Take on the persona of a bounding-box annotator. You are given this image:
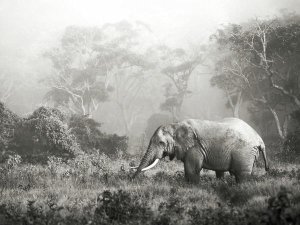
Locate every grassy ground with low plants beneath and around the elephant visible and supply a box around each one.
[0,154,300,224]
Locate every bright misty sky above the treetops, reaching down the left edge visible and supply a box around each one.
[0,0,300,133]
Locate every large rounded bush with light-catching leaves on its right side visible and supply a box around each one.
[14,107,79,163]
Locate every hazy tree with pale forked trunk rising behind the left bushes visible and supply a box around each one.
[45,26,111,115]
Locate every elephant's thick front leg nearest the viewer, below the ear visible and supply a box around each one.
[184,148,204,184]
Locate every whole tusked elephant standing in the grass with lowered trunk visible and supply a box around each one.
[132,118,269,183]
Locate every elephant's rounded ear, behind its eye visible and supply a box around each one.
[174,125,196,149]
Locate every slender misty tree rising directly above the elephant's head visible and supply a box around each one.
[158,46,203,121]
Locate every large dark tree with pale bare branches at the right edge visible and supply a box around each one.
[211,12,300,139]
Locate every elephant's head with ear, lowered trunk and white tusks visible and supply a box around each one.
[132,123,196,178]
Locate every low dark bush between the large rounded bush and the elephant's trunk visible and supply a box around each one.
[69,114,127,156]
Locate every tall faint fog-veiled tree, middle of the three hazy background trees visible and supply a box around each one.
[97,21,152,134]
